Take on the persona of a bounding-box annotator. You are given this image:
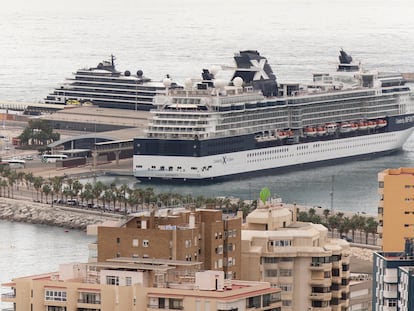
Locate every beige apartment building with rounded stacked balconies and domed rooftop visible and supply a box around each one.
[241,204,350,311]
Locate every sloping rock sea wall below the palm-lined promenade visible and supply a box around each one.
[0,197,120,230]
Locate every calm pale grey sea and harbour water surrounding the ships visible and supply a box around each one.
[0,0,414,304]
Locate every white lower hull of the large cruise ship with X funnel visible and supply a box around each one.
[133,115,414,181]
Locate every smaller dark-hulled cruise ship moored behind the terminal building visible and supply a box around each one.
[45,55,180,110]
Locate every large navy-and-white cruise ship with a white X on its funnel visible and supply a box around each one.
[133,50,414,181]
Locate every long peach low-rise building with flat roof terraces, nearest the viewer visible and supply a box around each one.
[2,258,281,311]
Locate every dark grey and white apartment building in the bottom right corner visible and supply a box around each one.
[372,238,414,311]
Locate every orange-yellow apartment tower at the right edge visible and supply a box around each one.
[377,167,414,252]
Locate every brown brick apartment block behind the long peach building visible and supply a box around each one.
[90,209,242,279]
